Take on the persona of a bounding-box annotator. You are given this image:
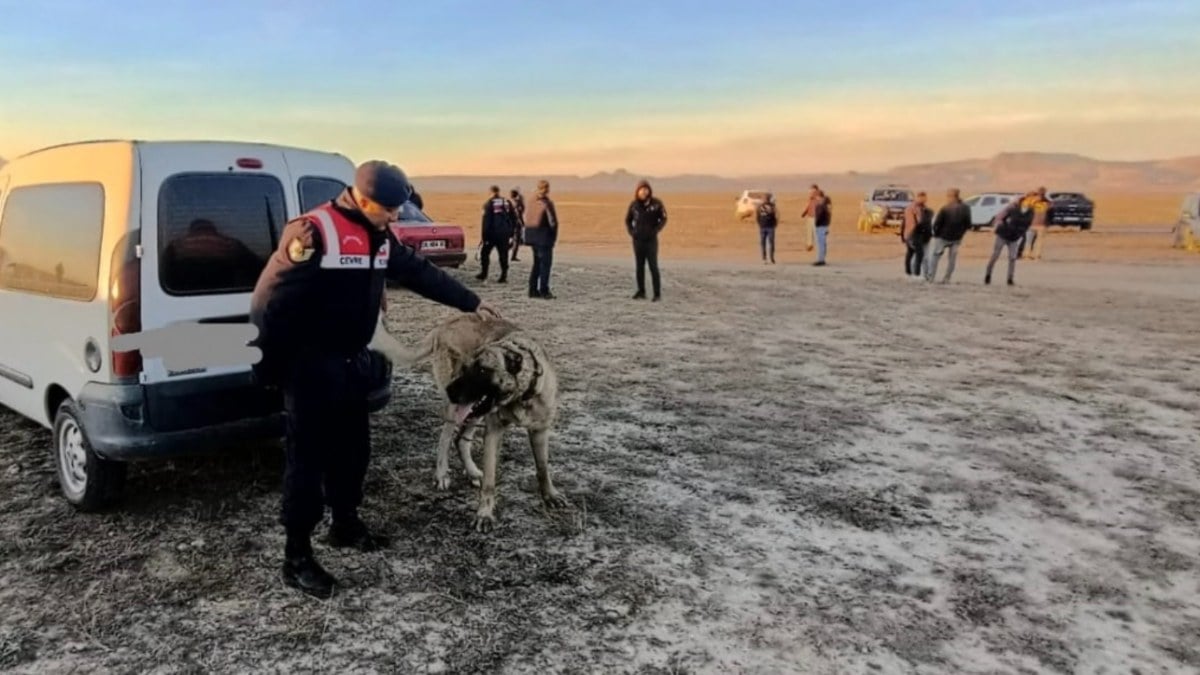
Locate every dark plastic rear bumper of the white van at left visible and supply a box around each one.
[79,372,284,461]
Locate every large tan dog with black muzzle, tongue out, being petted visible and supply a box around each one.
[371,313,568,532]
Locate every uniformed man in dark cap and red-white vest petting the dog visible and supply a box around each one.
[251,161,497,598]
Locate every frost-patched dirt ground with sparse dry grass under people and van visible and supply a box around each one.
[0,198,1200,675]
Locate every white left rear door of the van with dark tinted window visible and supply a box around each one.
[139,143,295,383]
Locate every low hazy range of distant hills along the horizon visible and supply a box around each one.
[413,153,1200,193]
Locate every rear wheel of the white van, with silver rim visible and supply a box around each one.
[54,399,127,512]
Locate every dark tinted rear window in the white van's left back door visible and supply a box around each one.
[158,173,287,295]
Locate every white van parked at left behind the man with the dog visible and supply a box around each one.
[0,141,386,510]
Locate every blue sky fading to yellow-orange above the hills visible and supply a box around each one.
[0,0,1200,174]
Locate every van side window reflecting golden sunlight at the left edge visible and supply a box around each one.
[0,183,104,301]
